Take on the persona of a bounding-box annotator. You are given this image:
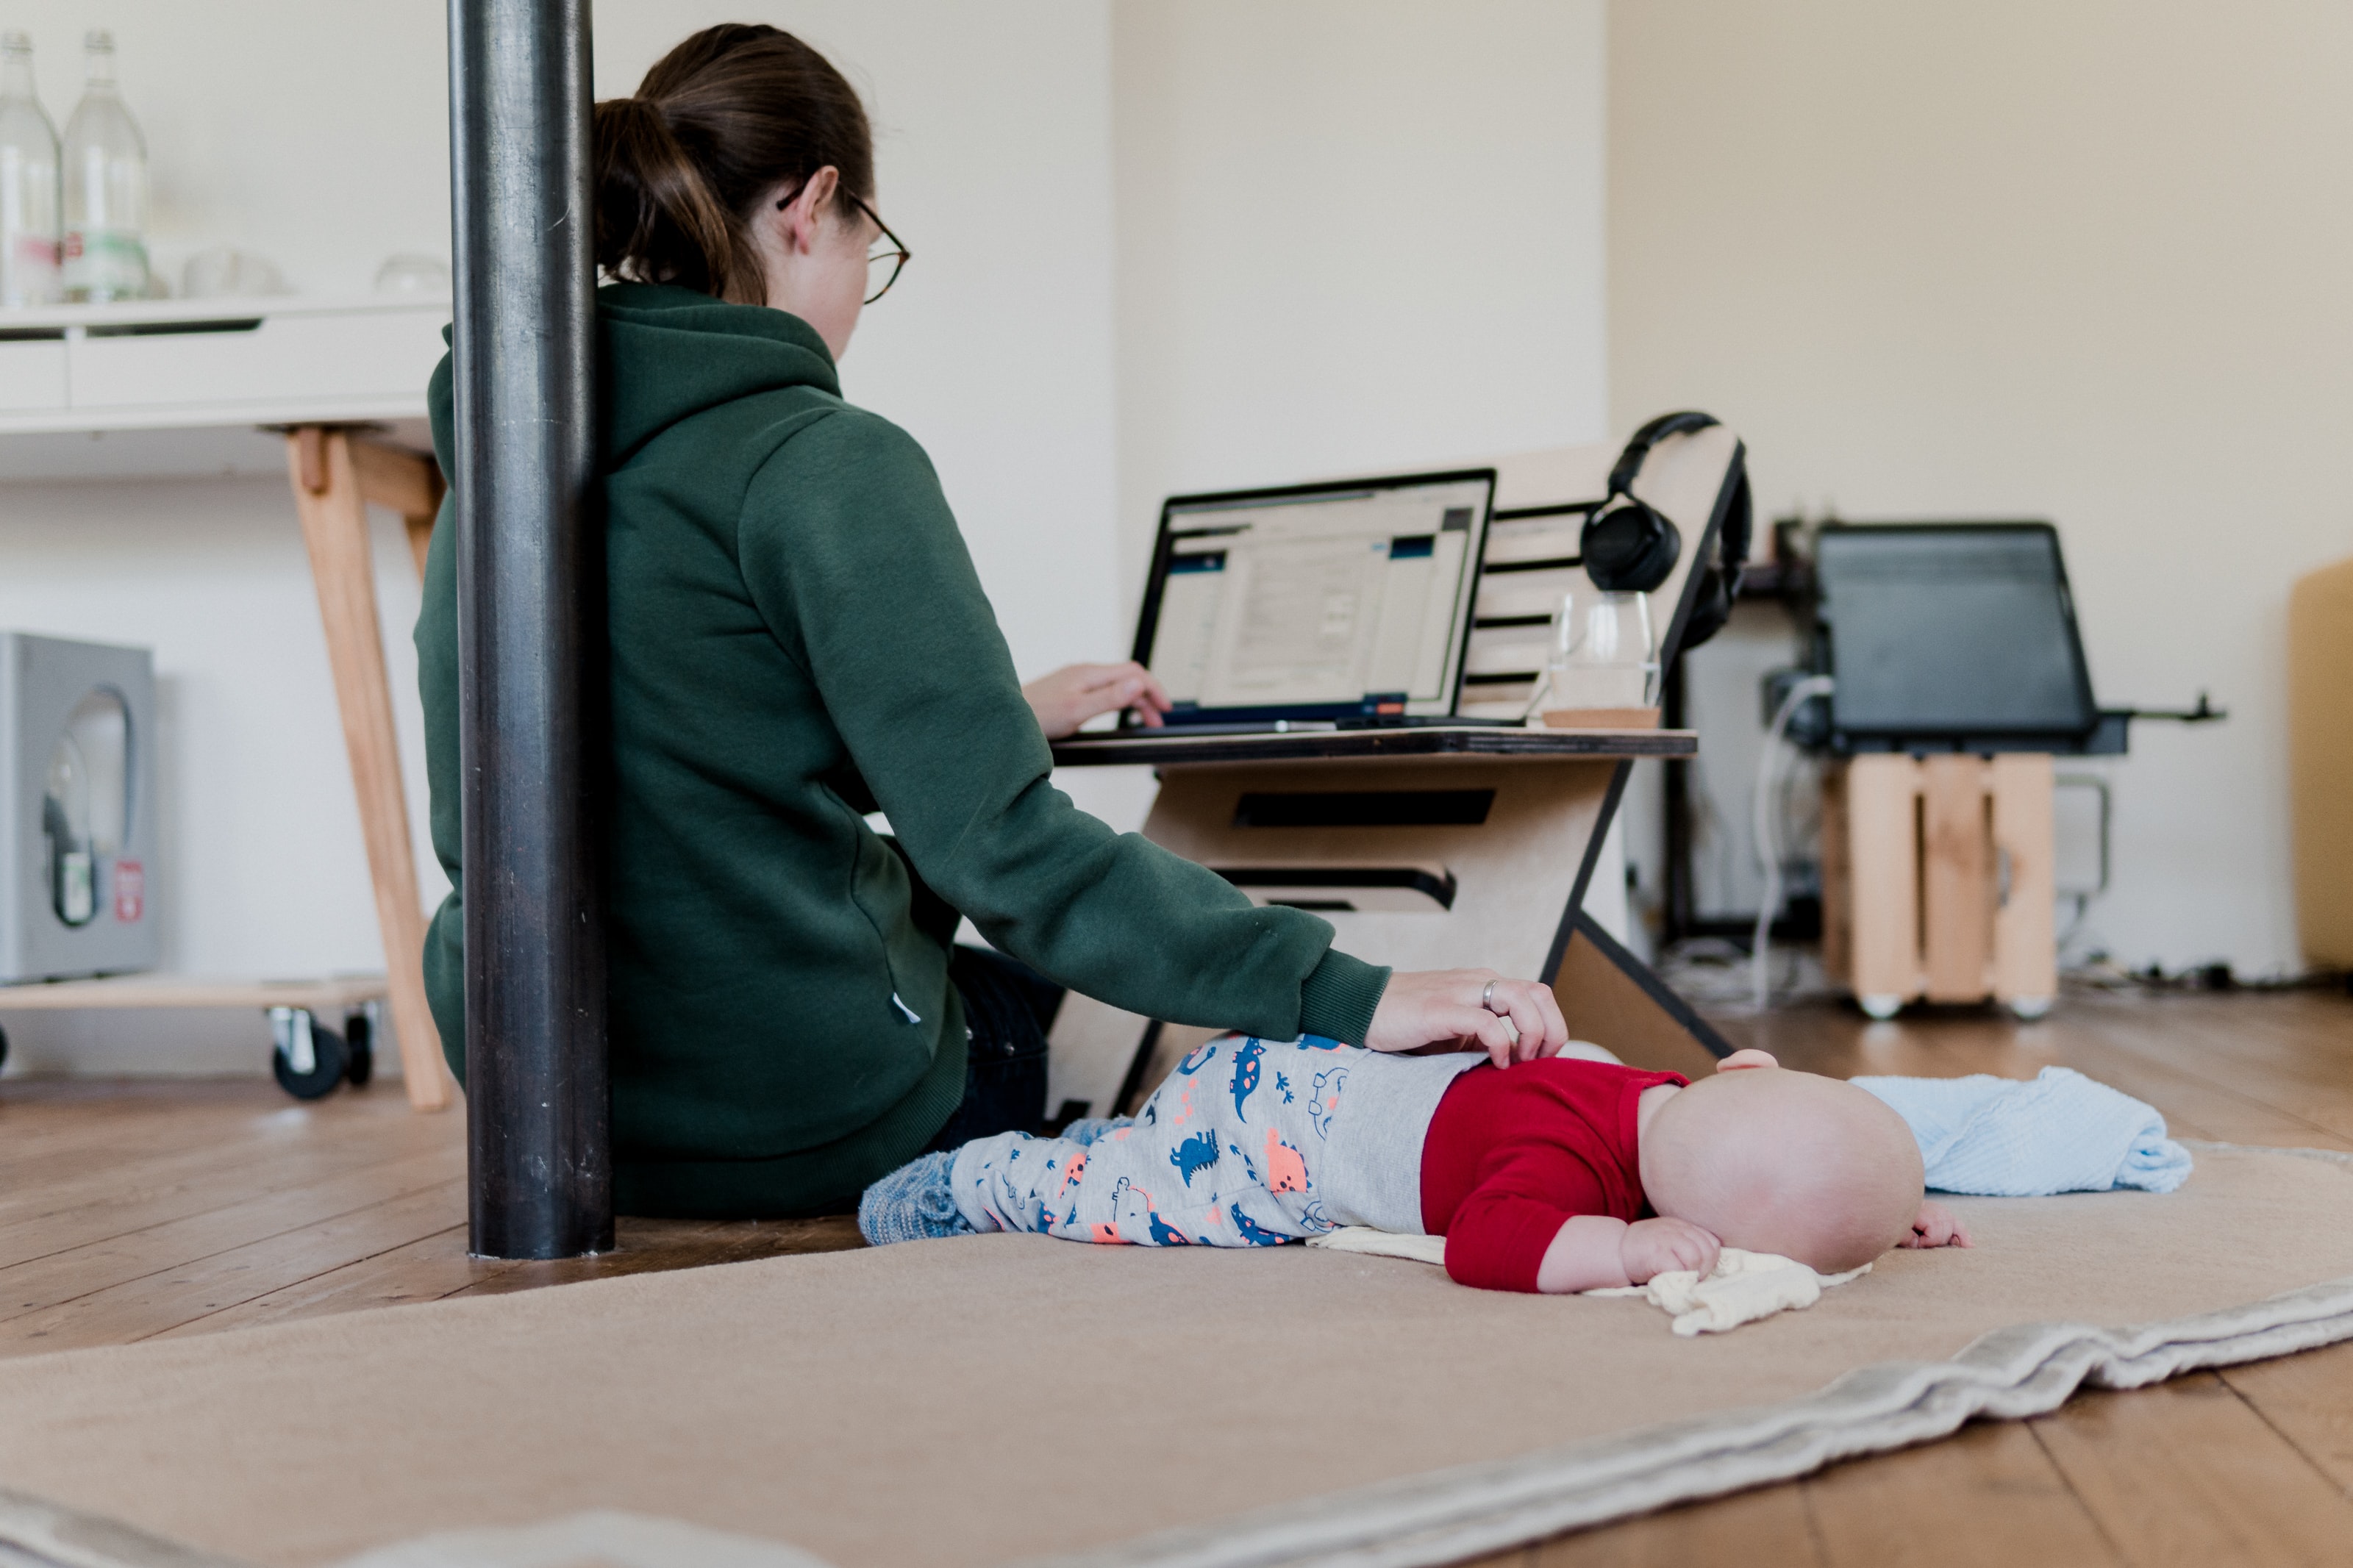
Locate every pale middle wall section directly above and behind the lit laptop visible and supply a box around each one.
[1113,0,1604,606]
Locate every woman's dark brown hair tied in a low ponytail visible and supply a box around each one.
[596,21,875,306]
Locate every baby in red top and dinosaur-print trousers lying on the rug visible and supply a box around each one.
[859,1034,1969,1293]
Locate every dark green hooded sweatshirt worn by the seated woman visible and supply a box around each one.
[416,284,1388,1215]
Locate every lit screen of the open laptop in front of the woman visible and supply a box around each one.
[1137,468,1494,724]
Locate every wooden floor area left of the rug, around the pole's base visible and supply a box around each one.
[0,1079,861,1356]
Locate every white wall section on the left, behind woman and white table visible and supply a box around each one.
[0,0,1125,1070]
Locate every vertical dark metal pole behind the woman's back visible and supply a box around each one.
[449,0,612,1258]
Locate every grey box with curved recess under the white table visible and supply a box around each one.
[0,632,160,983]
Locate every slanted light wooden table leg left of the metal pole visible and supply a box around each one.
[287,426,449,1109]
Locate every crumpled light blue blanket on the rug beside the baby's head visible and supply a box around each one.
[1854,1067,2190,1197]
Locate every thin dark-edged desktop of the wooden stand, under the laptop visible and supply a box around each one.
[1054,724,1699,769]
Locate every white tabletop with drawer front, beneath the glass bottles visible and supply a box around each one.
[0,294,449,479]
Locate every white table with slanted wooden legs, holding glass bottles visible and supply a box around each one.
[0,296,451,1109]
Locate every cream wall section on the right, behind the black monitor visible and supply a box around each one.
[1610,0,2353,969]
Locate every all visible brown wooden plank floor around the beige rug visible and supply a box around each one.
[0,995,2353,1568]
